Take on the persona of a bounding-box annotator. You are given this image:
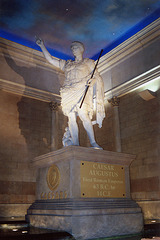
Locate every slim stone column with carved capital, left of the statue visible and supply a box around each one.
[49,102,59,151]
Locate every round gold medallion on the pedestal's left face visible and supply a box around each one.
[47,164,60,191]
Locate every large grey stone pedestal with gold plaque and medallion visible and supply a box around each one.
[26,146,143,239]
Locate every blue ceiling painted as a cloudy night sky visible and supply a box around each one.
[0,0,160,59]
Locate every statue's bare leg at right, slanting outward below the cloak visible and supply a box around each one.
[78,109,102,149]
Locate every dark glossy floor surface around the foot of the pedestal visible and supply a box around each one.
[0,218,160,240]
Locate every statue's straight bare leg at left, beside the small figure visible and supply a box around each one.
[68,112,79,146]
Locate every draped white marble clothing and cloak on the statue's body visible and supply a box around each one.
[60,58,105,127]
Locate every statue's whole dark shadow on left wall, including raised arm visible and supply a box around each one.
[4,46,51,159]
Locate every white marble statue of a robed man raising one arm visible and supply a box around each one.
[36,38,105,149]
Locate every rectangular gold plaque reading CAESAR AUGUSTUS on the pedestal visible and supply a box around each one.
[81,161,126,198]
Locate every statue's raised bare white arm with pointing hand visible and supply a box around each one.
[36,37,59,68]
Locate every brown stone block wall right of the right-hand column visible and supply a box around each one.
[119,89,160,219]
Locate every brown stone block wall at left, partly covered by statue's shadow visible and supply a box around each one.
[0,90,51,216]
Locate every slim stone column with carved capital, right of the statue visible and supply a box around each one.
[108,96,121,152]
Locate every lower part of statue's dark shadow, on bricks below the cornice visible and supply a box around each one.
[17,97,51,159]
